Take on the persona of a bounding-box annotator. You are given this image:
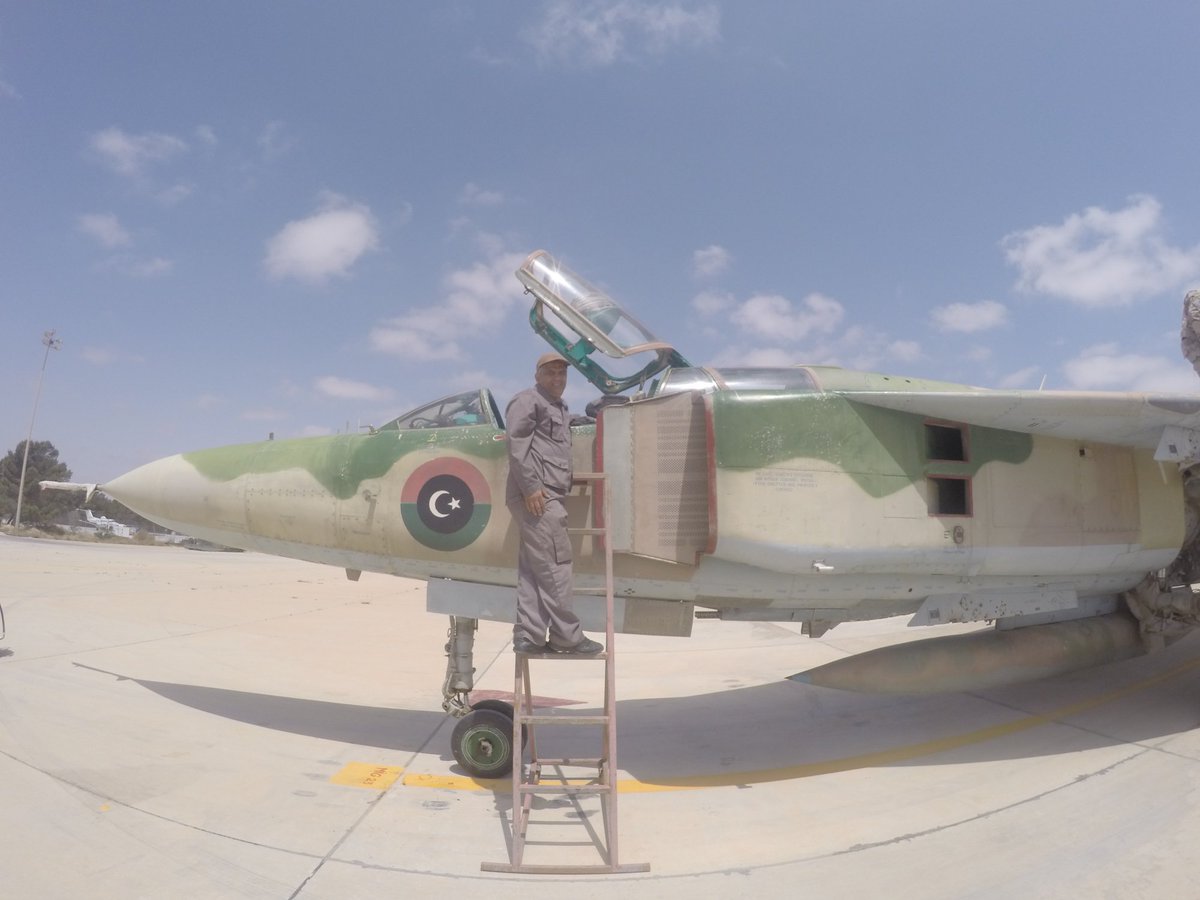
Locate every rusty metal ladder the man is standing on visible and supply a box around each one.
[480,472,650,875]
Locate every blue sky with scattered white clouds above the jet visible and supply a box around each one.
[0,0,1200,481]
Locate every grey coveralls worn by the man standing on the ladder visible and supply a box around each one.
[504,386,583,649]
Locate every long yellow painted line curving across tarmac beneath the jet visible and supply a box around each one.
[386,659,1200,793]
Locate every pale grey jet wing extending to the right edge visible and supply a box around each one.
[839,391,1200,458]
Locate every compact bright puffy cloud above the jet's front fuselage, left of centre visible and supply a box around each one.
[263,192,379,283]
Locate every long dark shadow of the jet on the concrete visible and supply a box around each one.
[76,648,1200,785]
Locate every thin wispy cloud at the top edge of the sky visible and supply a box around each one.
[523,0,721,66]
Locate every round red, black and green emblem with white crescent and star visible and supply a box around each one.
[400,456,492,551]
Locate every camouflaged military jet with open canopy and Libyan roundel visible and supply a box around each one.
[49,251,1200,775]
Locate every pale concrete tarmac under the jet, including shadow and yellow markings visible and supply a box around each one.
[0,535,1200,900]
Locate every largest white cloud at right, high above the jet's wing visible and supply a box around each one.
[1002,194,1200,307]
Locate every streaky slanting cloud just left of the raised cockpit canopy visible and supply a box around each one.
[370,250,524,361]
